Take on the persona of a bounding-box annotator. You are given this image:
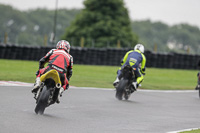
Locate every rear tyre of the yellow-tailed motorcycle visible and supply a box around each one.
[35,86,50,115]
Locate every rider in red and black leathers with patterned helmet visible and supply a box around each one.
[32,40,73,103]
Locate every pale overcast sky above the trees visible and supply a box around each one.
[0,0,200,28]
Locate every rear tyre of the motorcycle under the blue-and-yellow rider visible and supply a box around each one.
[115,78,128,100]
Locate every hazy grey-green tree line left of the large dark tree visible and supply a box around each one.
[0,4,80,46]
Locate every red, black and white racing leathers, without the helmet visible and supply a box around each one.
[36,49,73,90]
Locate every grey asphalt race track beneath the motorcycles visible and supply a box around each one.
[0,86,200,133]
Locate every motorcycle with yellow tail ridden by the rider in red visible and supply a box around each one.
[35,69,62,114]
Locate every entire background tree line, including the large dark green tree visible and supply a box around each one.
[0,0,200,54]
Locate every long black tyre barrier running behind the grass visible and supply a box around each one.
[0,44,200,69]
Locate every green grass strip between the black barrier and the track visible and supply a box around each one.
[0,59,198,90]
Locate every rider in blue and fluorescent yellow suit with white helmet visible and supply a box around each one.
[113,44,146,89]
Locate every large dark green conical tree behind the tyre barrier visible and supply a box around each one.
[63,0,138,47]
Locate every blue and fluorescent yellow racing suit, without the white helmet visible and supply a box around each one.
[117,50,146,85]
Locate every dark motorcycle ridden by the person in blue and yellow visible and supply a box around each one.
[115,65,136,100]
